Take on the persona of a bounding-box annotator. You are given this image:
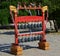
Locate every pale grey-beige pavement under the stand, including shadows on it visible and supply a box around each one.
[0,30,60,56]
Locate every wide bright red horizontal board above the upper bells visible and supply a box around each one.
[15,16,44,23]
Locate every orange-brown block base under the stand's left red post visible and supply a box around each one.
[11,43,23,55]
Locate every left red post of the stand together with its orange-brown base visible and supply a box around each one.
[11,12,23,55]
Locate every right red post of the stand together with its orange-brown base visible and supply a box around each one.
[38,12,49,50]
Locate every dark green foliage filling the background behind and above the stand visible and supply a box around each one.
[0,0,60,25]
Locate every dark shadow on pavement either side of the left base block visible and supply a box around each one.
[0,44,38,54]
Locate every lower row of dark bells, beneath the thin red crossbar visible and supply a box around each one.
[19,35,42,43]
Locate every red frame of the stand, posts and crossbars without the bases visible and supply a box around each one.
[12,8,46,44]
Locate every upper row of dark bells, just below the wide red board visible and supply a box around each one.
[18,23,42,29]
